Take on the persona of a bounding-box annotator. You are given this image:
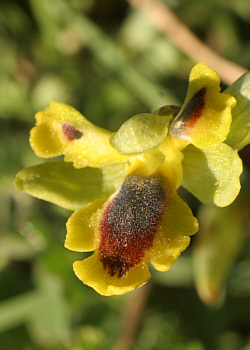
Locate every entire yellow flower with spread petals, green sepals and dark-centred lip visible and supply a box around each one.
[15,62,246,295]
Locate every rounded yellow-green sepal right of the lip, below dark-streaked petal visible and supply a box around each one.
[182,143,242,207]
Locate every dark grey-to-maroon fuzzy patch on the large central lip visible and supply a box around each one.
[99,173,166,278]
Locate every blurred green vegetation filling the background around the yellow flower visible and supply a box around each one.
[0,0,250,350]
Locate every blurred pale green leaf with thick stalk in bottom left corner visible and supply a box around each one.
[0,270,71,346]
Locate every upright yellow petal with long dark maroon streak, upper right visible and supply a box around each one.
[171,62,236,149]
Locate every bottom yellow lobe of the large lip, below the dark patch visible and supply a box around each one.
[73,252,150,296]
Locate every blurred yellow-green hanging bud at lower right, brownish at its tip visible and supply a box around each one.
[193,198,249,304]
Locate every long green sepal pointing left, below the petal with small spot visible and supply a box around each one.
[14,161,126,210]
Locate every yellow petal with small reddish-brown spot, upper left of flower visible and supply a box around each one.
[30,102,128,168]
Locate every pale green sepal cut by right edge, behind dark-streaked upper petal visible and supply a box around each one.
[224,72,250,149]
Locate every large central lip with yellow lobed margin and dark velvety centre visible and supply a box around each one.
[65,161,198,295]
